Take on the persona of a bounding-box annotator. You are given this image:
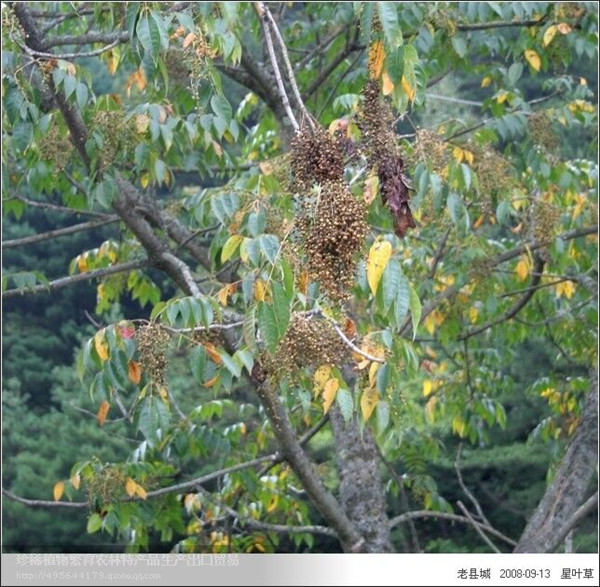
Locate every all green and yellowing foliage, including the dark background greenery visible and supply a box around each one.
[2,2,598,552]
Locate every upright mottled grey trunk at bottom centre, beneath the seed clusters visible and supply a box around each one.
[330,406,393,553]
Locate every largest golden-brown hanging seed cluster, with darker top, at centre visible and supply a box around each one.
[291,129,368,301]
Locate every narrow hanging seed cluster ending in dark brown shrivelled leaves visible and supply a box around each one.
[359,79,416,238]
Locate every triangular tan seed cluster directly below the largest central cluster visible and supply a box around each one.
[267,314,350,375]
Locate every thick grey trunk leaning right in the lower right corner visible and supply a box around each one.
[515,371,598,552]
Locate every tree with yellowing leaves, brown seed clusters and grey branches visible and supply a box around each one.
[3,2,598,552]
